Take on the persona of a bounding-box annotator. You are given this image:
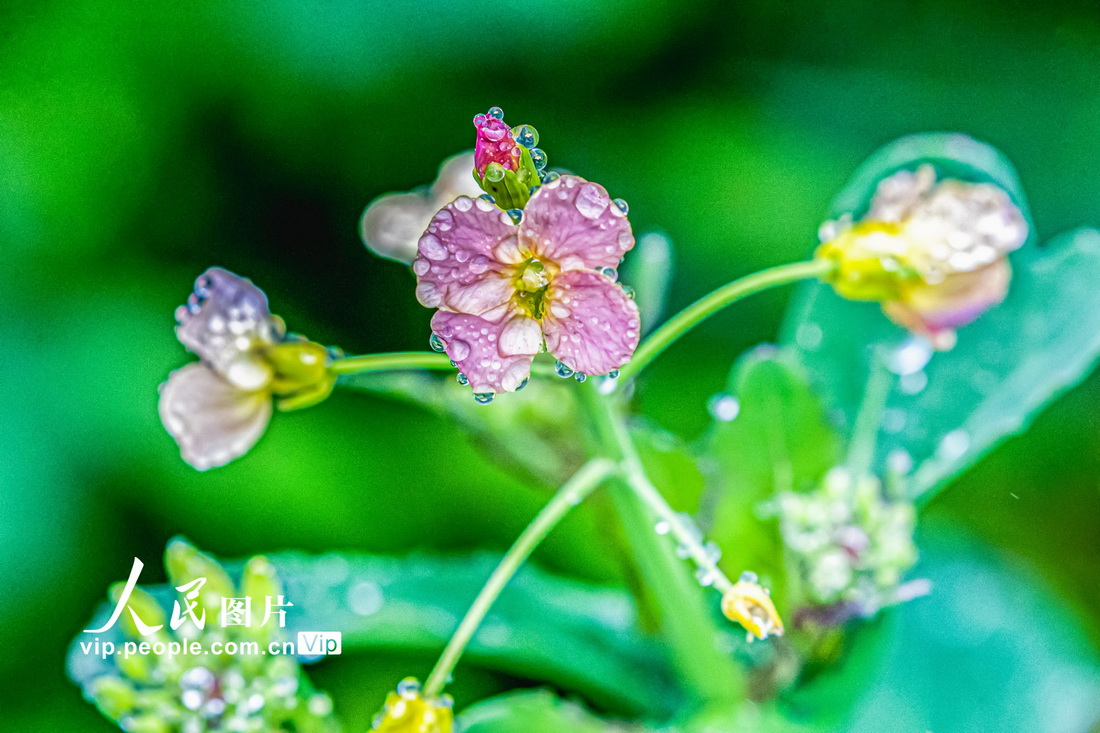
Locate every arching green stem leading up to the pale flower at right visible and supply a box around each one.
[619,260,835,384]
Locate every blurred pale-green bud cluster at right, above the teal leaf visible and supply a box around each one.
[778,468,920,619]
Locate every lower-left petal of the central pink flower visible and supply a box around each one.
[431,306,542,393]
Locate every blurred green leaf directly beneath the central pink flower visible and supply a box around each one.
[339,372,585,485]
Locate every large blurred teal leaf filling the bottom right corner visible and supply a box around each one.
[789,522,1100,733]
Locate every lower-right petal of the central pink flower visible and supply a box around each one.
[542,270,640,374]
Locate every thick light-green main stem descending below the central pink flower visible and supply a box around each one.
[576,383,743,705]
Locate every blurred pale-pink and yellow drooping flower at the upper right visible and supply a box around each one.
[816,165,1027,349]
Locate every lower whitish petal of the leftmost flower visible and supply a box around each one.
[160,363,272,471]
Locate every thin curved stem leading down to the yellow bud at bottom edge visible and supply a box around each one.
[424,459,615,700]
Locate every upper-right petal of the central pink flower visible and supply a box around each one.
[520,176,634,270]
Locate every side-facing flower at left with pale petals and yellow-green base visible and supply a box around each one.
[160,267,336,471]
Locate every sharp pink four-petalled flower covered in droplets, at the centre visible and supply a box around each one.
[413,176,639,393]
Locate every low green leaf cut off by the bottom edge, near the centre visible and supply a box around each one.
[458,690,646,733]
